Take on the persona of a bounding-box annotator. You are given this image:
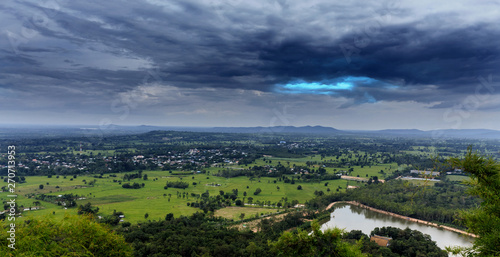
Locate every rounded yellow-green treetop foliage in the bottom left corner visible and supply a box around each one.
[0,215,133,257]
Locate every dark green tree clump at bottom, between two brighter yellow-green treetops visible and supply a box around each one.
[120,210,302,257]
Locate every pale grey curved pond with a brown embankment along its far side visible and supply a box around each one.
[321,203,474,249]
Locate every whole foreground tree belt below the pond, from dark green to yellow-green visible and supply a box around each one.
[119,209,447,257]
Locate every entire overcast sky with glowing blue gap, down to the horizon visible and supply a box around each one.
[0,0,500,130]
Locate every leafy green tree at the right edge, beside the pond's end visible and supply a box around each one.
[447,146,500,256]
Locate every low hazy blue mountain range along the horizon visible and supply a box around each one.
[0,125,500,139]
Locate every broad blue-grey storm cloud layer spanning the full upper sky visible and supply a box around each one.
[0,0,500,115]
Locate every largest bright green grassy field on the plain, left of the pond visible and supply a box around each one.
[0,171,355,222]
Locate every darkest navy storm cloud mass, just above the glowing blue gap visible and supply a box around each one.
[254,25,500,100]
